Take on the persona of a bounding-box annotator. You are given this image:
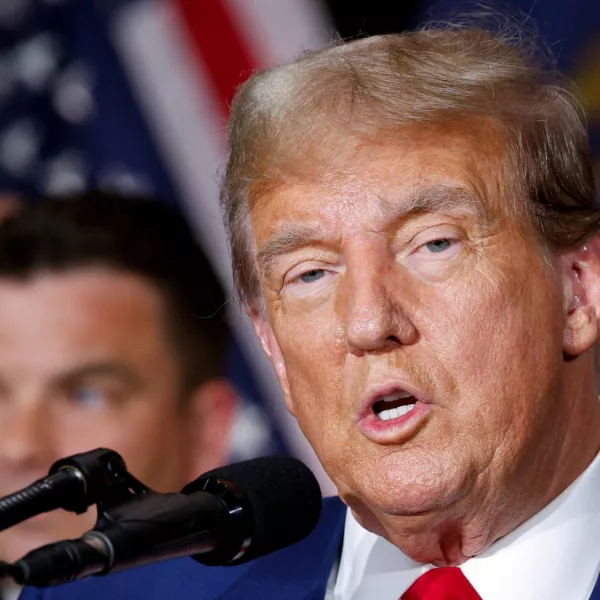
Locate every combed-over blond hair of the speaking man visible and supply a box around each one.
[221,18,600,309]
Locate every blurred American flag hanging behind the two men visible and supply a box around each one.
[0,0,332,491]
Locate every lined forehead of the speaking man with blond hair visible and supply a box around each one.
[251,128,510,244]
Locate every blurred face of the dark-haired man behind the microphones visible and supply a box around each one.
[0,269,223,560]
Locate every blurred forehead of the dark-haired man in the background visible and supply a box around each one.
[0,268,169,355]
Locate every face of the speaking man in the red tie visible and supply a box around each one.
[251,133,596,560]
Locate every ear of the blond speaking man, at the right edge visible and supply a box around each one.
[561,236,600,356]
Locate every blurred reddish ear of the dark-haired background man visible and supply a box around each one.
[185,379,238,480]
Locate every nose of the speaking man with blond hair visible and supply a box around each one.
[340,255,419,356]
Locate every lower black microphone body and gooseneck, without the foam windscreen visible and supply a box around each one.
[0,462,252,587]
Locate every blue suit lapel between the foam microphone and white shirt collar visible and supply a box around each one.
[218,498,346,600]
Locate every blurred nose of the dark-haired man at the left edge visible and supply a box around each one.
[0,402,54,472]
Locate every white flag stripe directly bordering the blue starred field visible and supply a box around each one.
[112,0,335,495]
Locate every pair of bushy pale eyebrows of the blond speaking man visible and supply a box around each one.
[256,185,487,274]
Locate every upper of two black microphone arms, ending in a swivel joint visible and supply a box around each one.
[0,448,141,531]
